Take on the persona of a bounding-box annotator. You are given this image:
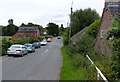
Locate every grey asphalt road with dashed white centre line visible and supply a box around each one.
[2,38,63,80]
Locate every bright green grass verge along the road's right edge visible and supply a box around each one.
[60,46,86,80]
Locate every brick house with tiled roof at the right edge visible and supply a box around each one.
[95,0,120,52]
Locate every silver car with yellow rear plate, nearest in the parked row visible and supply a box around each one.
[7,44,28,56]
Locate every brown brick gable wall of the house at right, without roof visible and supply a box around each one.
[95,8,112,54]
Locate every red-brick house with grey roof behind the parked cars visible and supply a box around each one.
[12,27,40,38]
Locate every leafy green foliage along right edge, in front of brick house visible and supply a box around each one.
[107,13,120,80]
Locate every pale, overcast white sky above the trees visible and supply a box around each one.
[0,0,105,27]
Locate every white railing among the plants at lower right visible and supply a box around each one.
[86,55,108,82]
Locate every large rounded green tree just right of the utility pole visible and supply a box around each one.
[71,8,100,36]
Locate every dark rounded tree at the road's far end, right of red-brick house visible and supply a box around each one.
[46,23,59,36]
